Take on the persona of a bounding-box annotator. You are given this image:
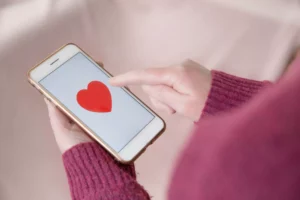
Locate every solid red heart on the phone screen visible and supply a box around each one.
[77,81,112,112]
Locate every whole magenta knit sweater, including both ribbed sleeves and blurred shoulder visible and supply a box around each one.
[63,59,300,200]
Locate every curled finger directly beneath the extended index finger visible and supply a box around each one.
[143,85,188,114]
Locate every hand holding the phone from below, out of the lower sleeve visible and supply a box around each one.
[45,99,93,153]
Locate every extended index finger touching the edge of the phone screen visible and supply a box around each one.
[109,68,173,87]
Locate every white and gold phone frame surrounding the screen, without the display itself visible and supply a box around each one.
[28,44,166,163]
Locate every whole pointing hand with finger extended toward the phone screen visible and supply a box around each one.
[110,60,211,121]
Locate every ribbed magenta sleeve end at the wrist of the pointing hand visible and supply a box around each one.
[202,70,271,117]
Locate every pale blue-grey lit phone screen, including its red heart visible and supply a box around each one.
[39,53,155,152]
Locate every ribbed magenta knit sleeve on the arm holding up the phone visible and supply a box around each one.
[63,143,150,200]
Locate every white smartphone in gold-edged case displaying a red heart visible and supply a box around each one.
[28,44,165,163]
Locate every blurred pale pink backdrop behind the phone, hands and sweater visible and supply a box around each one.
[0,0,300,200]
